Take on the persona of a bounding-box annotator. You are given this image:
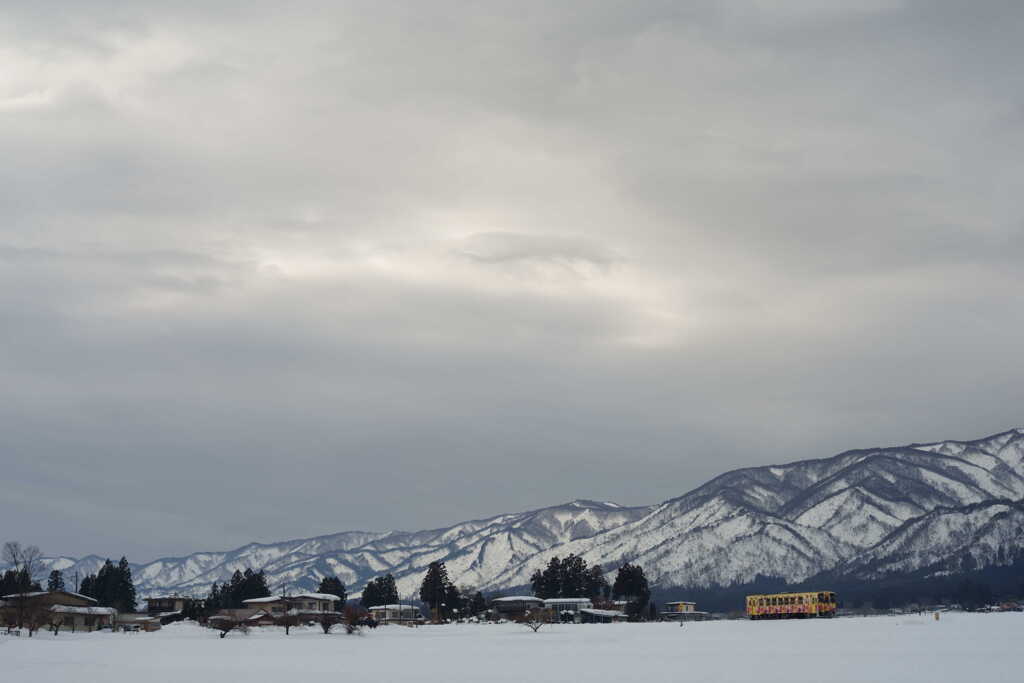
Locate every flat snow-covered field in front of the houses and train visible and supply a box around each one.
[0,613,1024,683]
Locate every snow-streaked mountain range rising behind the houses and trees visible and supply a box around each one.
[22,429,1024,595]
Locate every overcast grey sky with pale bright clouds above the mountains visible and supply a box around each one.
[0,0,1024,561]
